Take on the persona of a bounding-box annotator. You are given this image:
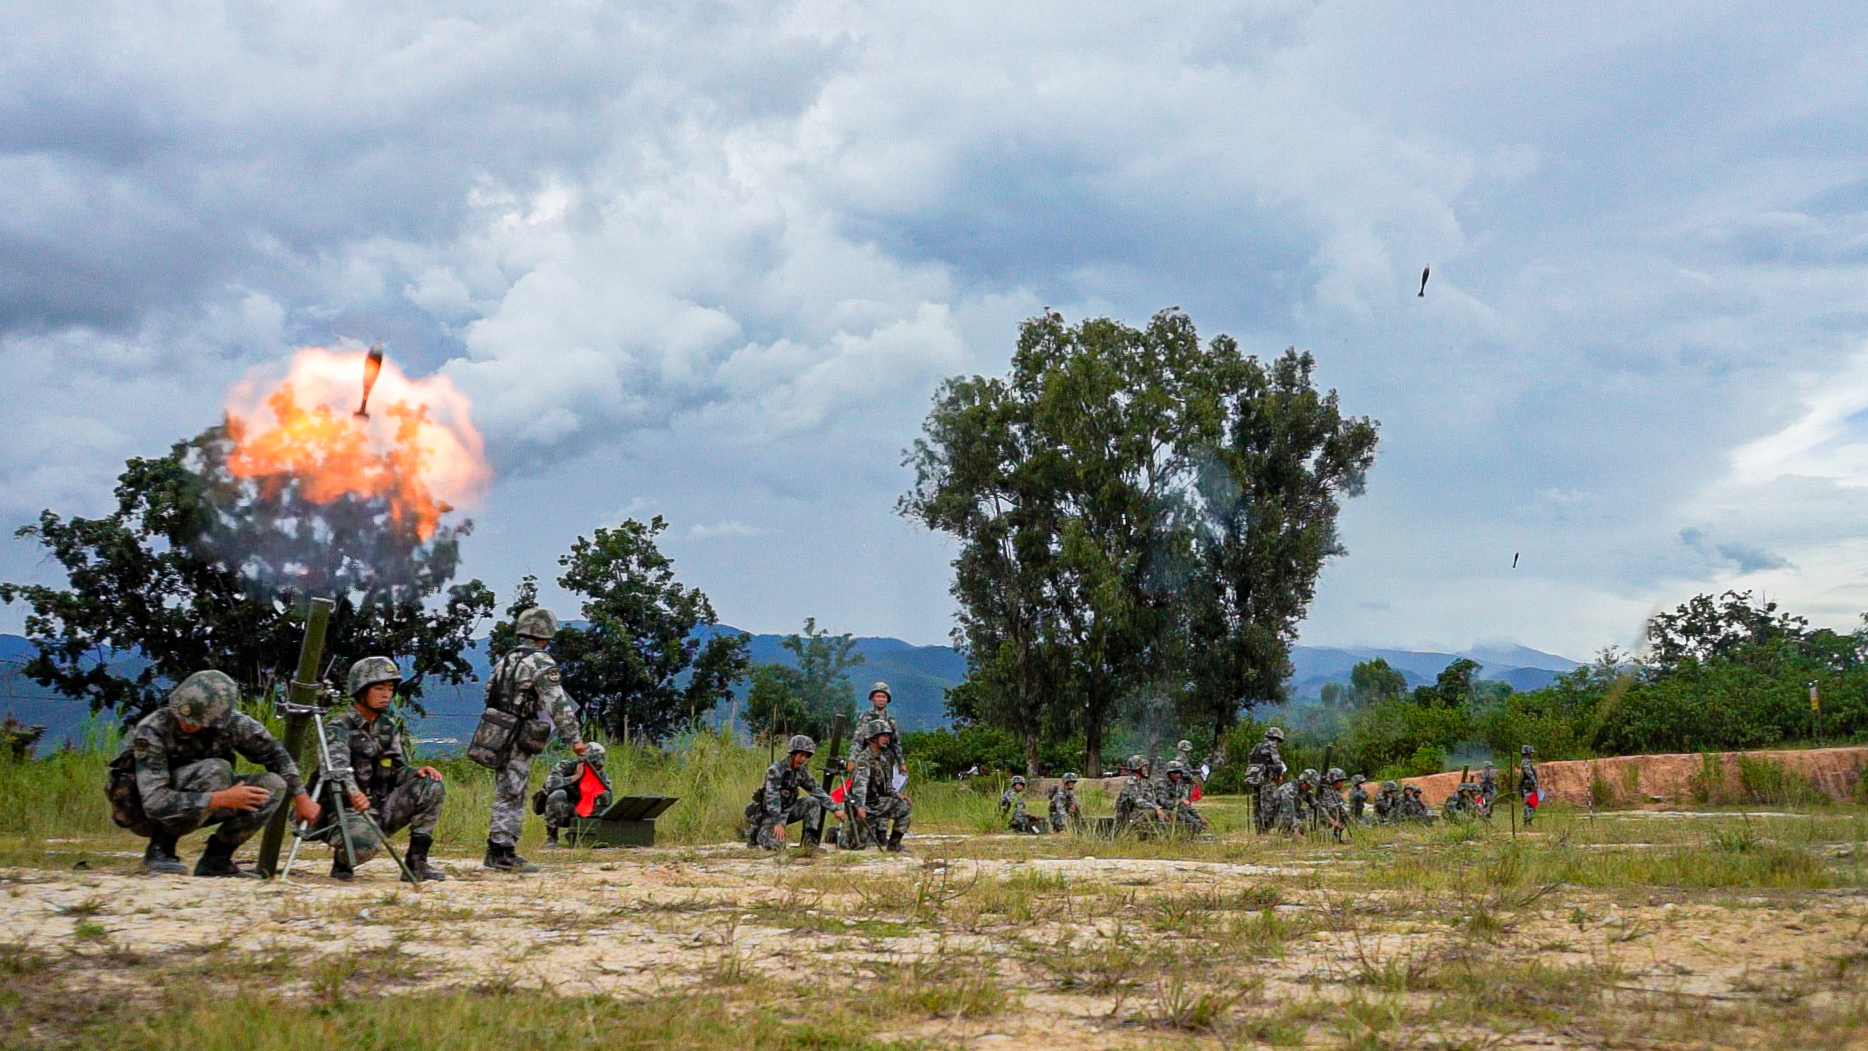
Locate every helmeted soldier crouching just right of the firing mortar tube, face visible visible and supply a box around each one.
[319,657,448,881]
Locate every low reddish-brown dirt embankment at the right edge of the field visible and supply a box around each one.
[1367,749,1868,806]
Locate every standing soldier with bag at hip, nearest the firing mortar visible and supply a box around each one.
[469,607,588,872]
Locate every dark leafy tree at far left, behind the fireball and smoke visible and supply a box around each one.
[0,420,493,721]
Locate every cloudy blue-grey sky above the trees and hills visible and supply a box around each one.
[0,0,1868,659]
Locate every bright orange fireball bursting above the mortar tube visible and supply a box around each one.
[226,347,491,540]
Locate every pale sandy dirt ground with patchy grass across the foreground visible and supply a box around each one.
[0,810,1868,1049]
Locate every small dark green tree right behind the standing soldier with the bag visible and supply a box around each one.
[534,515,751,739]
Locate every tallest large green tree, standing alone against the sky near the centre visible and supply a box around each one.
[900,310,1375,773]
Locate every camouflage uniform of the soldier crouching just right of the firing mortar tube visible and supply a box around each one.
[319,708,446,868]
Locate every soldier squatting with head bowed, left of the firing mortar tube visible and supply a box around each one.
[105,672,318,876]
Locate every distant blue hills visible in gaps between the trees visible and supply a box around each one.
[0,625,1578,747]
